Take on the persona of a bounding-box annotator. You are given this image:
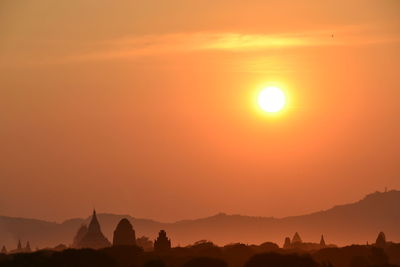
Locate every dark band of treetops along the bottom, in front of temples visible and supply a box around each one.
[0,242,400,267]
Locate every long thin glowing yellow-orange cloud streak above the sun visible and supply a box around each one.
[66,27,399,61]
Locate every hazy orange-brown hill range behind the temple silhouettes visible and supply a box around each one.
[0,190,400,249]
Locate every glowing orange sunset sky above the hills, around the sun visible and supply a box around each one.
[0,0,400,221]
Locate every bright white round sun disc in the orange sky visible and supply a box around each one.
[258,86,286,113]
